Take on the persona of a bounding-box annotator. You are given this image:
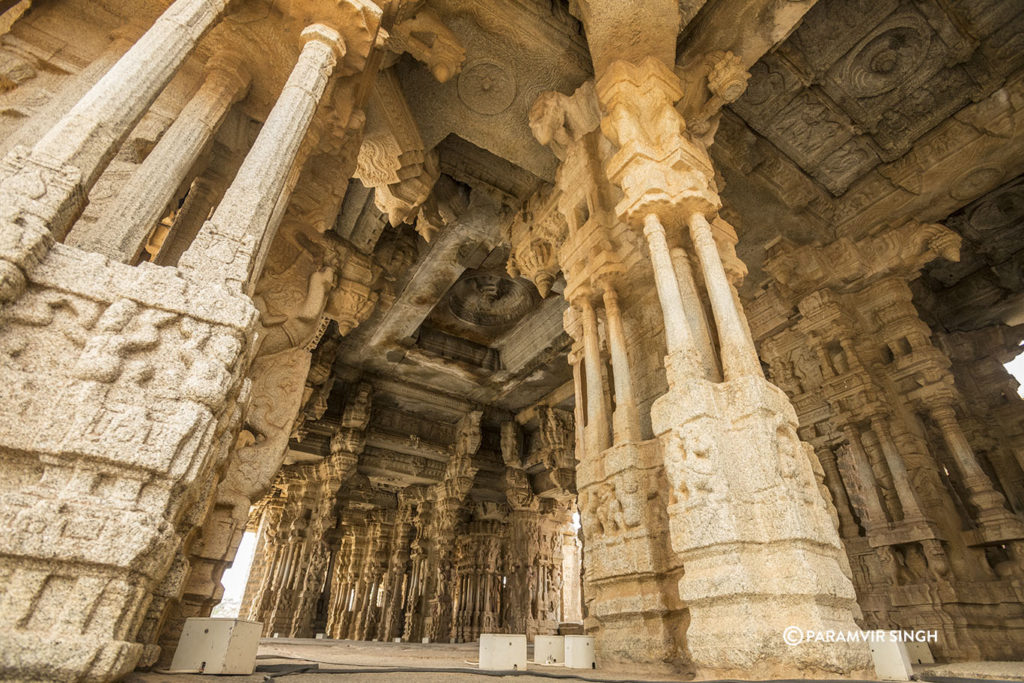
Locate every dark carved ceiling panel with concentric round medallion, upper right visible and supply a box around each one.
[731,0,1024,196]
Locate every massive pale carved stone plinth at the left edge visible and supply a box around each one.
[0,244,256,681]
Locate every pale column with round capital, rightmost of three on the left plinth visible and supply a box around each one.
[178,24,345,293]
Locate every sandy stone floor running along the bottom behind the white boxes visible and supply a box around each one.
[124,638,1024,683]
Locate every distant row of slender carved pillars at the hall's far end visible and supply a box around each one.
[236,486,580,642]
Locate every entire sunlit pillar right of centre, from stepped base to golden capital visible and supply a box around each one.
[593,56,870,677]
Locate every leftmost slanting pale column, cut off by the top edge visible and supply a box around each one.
[0,0,228,302]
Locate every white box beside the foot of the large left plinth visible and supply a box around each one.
[171,616,263,676]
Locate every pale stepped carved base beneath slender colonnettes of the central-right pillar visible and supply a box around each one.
[651,377,871,678]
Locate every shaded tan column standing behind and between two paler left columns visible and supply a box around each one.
[68,55,250,263]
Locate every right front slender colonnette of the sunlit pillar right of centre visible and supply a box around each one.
[689,213,761,380]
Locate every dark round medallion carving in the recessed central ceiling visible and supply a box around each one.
[449,273,536,328]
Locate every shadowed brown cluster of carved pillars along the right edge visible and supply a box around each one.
[753,233,1024,658]
